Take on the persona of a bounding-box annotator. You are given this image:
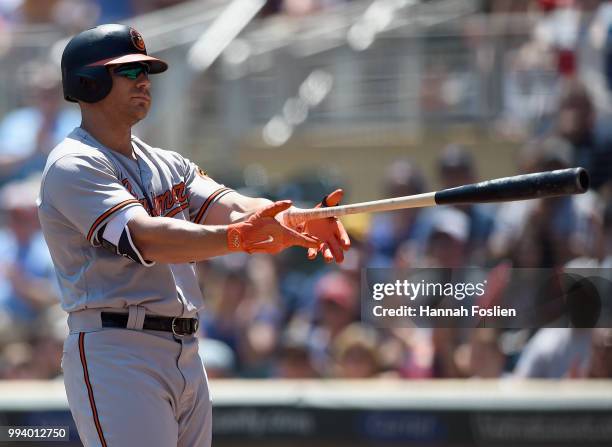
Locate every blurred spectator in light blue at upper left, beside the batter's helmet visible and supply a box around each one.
[0,62,80,185]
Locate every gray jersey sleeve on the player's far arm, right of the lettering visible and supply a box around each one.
[185,159,234,224]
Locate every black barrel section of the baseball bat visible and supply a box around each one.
[435,168,589,205]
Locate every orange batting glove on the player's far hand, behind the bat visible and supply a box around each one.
[299,189,351,264]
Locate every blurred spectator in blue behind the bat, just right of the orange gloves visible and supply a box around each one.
[368,160,427,267]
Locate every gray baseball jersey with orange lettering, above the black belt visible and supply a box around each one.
[39,127,232,317]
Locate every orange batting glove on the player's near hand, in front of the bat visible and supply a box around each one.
[227,200,319,254]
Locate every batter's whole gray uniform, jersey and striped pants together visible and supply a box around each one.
[39,128,222,447]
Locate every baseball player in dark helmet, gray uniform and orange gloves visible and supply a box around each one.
[39,25,350,447]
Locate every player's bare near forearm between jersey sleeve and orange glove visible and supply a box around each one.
[128,217,229,264]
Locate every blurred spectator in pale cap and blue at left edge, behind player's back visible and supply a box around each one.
[0,177,58,335]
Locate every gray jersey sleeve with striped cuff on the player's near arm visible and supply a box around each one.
[41,155,142,247]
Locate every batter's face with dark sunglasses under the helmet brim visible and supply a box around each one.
[99,62,151,125]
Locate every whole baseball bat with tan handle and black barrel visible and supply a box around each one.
[285,168,589,225]
